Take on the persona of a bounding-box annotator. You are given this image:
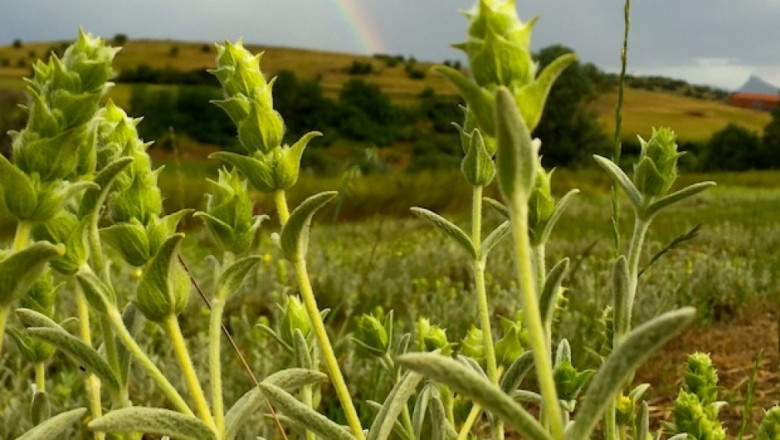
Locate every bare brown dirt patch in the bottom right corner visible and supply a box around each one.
[635,309,780,436]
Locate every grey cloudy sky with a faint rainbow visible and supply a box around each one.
[0,0,780,89]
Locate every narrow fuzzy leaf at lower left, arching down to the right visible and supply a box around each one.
[27,327,119,391]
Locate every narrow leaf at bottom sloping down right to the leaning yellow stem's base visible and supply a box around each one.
[259,382,355,440]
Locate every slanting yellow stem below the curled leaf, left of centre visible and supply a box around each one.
[292,254,365,440]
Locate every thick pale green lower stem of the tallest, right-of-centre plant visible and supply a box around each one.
[510,203,563,440]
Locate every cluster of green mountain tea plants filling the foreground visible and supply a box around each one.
[0,0,780,440]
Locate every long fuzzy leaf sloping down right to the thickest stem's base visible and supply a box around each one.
[398,353,551,440]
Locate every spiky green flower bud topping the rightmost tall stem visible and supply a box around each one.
[634,128,683,197]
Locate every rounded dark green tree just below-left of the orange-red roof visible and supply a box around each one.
[701,124,764,171]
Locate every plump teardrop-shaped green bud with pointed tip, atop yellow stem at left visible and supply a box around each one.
[133,234,190,322]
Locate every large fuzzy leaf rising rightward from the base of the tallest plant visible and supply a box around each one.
[566,307,696,440]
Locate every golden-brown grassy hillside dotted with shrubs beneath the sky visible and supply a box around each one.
[0,40,770,141]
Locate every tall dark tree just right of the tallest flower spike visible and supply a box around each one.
[534,46,609,167]
